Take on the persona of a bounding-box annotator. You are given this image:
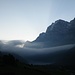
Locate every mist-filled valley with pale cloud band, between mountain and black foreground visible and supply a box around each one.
[0,40,75,64]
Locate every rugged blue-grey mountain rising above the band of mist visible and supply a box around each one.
[25,18,75,48]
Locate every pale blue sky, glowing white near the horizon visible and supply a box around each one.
[0,0,75,41]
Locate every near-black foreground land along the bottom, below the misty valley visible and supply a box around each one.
[0,53,75,75]
